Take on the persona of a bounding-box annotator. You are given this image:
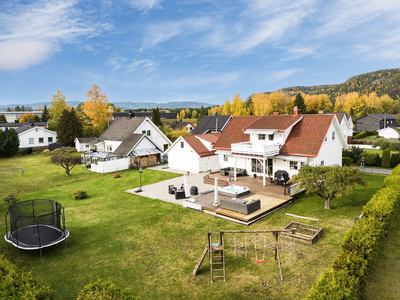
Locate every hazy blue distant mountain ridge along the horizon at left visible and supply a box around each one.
[0,101,213,111]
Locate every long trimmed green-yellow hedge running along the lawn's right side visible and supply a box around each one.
[307,166,400,300]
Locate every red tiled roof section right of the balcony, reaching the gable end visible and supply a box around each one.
[279,114,335,157]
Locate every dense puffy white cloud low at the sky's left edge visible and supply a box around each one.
[0,40,57,70]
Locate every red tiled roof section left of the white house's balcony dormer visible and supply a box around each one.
[214,116,260,150]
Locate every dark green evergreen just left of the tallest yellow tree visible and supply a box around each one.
[57,108,83,146]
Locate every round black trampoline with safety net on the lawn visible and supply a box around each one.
[4,199,69,258]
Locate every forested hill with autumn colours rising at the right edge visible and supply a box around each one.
[279,69,400,103]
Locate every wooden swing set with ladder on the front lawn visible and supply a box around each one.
[193,229,290,283]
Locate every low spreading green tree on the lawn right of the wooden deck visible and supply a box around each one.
[289,165,367,209]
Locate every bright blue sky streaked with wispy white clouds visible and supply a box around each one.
[0,0,400,104]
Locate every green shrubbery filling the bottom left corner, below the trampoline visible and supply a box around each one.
[0,255,54,300]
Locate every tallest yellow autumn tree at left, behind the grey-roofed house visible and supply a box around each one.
[82,84,111,134]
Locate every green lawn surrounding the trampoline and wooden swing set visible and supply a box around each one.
[0,155,384,299]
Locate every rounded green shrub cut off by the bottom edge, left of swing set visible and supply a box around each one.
[77,279,135,300]
